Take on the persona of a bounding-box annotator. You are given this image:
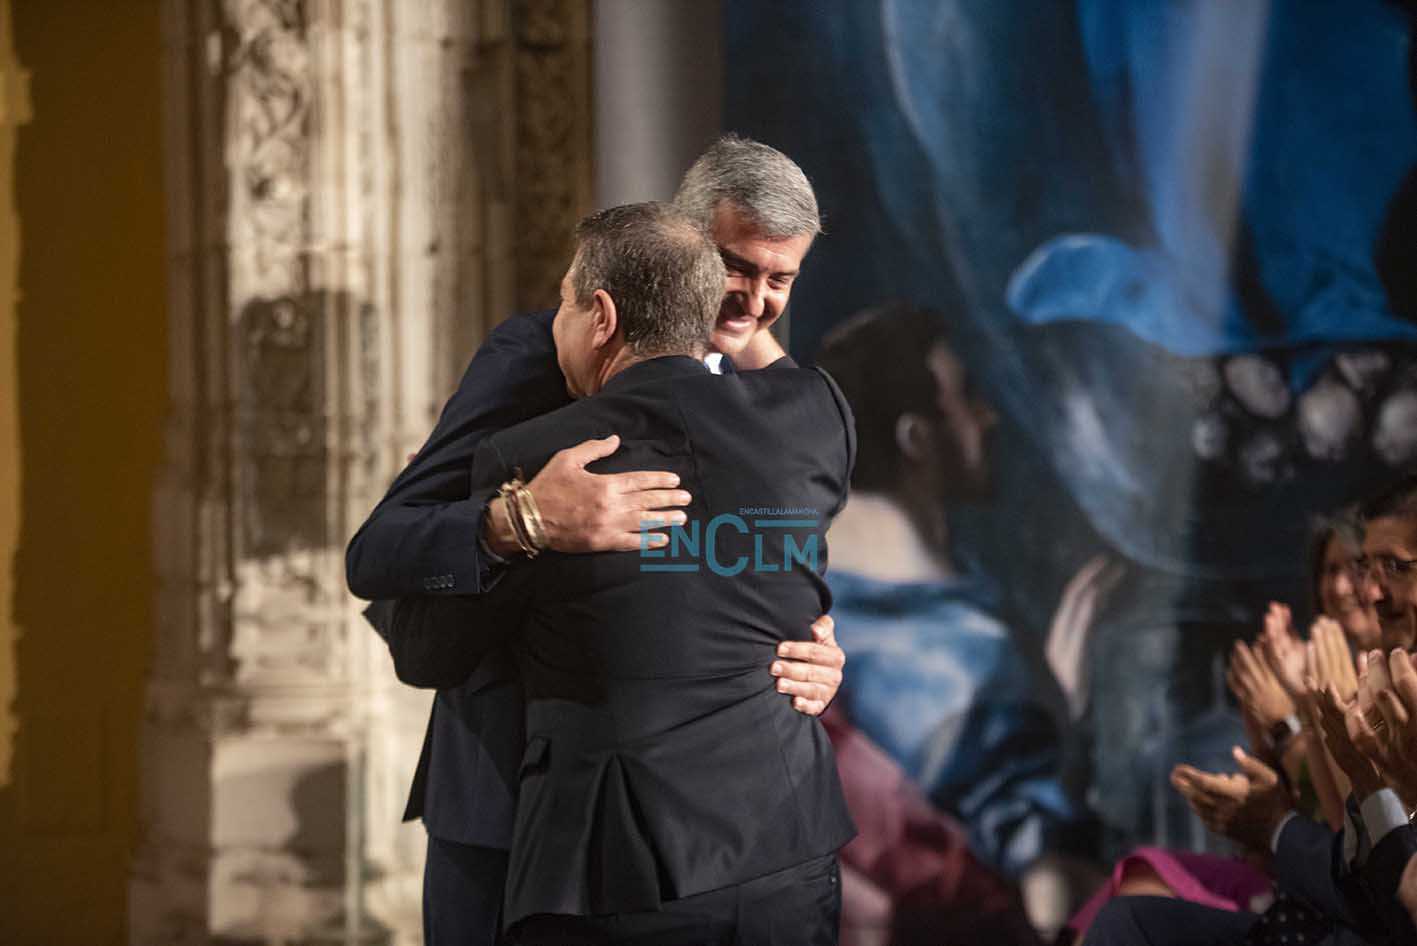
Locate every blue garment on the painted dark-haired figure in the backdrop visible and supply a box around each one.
[828,571,1077,874]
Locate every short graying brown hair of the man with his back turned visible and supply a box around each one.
[571,203,728,357]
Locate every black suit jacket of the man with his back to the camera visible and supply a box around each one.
[391,358,854,923]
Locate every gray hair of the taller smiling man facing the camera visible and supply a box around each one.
[674,135,822,239]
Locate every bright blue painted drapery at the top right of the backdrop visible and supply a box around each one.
[1008,0,1417,354]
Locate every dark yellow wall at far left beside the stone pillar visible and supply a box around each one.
[0,0,167,946]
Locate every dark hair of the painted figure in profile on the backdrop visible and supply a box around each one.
[816,303,947,491]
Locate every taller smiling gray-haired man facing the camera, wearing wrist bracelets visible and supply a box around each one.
[346,136,845,946]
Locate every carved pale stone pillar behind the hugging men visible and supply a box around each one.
[130,0,591,946]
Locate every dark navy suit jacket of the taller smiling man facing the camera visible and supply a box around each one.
[346,312,570,848]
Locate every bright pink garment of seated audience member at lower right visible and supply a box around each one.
[1068,847,1272,930]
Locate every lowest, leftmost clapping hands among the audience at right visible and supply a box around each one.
[1170,746,1294,854]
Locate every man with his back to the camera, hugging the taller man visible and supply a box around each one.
[390,204,854,946]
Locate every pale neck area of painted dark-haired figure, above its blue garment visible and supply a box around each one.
[826,493,956,582]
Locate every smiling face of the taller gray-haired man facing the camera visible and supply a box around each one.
[711,203,812,357]
